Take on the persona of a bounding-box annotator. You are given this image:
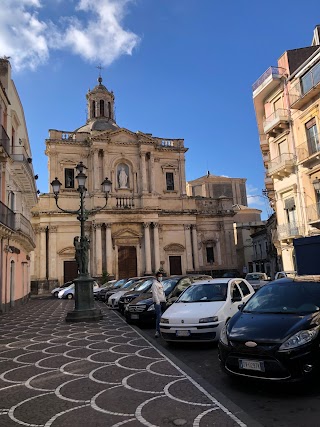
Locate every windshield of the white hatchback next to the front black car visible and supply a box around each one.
[177,283,228,302]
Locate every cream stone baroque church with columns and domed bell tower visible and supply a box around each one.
[32,77,260,288]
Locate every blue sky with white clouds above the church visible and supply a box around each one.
[0,0,320,219]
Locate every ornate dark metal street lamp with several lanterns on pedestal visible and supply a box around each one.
[51,162,112,322]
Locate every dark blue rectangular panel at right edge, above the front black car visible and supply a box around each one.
[293,236,320,275]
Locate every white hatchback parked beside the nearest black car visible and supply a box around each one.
[160,278,254,342]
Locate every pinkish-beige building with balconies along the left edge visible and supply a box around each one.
[0,58,37,313]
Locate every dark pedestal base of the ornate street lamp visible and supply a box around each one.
[66,274,103,322]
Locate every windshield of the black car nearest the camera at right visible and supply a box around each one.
[243,281,320,315]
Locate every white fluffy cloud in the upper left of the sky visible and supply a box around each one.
[0,0,139,70]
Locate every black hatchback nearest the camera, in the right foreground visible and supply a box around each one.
[218,276,320,381]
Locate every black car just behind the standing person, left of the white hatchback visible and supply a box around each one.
[124,274,212,323]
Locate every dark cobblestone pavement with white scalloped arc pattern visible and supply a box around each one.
[0,298,250,427]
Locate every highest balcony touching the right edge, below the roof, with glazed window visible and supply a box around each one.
[289,62,320,109]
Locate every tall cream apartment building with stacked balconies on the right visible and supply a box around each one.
[253,26,320,270]
